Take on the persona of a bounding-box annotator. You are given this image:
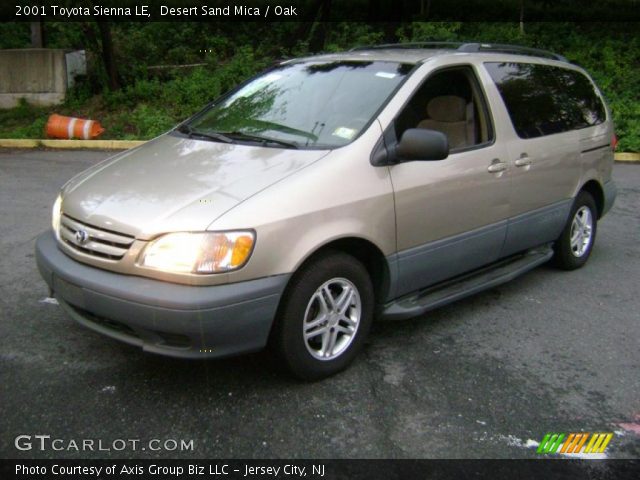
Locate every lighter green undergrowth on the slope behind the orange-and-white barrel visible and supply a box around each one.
[0,48,271,140]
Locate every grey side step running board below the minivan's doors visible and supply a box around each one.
[379,246,553,320]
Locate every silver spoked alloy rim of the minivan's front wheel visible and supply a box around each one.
[302,278,362,360]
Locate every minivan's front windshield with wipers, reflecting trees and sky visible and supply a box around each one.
[179,61,412,148]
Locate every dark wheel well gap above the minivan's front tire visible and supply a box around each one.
[299,237,391,302]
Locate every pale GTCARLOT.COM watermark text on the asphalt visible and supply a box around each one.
[13,435,195,452]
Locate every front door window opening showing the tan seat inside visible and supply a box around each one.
[395,67,493,152]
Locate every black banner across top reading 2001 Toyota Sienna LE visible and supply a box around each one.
[0,0,640,22]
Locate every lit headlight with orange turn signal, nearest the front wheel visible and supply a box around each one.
[140,231,255,273]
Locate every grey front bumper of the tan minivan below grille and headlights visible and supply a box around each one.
[36,231,289,358]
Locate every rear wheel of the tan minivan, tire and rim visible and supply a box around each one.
[554,191,598,270]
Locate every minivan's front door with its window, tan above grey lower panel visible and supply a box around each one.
[390,66,510,296]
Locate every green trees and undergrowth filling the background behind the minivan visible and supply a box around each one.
[0,21,640,151]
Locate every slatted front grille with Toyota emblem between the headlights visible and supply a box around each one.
[60,215,135,260]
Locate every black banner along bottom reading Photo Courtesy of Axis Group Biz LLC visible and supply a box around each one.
[0,459,640,480]
